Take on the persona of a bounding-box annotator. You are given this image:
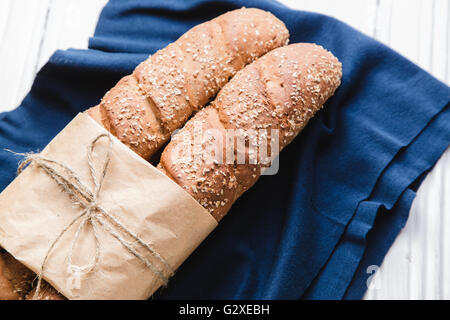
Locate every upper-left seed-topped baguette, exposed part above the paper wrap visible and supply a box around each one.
[87,8,289,160]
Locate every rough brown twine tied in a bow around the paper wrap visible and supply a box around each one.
[11,133,173,299]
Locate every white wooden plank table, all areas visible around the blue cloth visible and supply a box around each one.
[0,0,450,299]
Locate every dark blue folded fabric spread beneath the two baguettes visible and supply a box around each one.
[0,0,450,299]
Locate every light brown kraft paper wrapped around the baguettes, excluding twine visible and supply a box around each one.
[0,114,217,299]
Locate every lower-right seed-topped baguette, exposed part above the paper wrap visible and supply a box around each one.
[158,43,342,221]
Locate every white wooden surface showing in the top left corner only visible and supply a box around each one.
[0,0,107,111]
